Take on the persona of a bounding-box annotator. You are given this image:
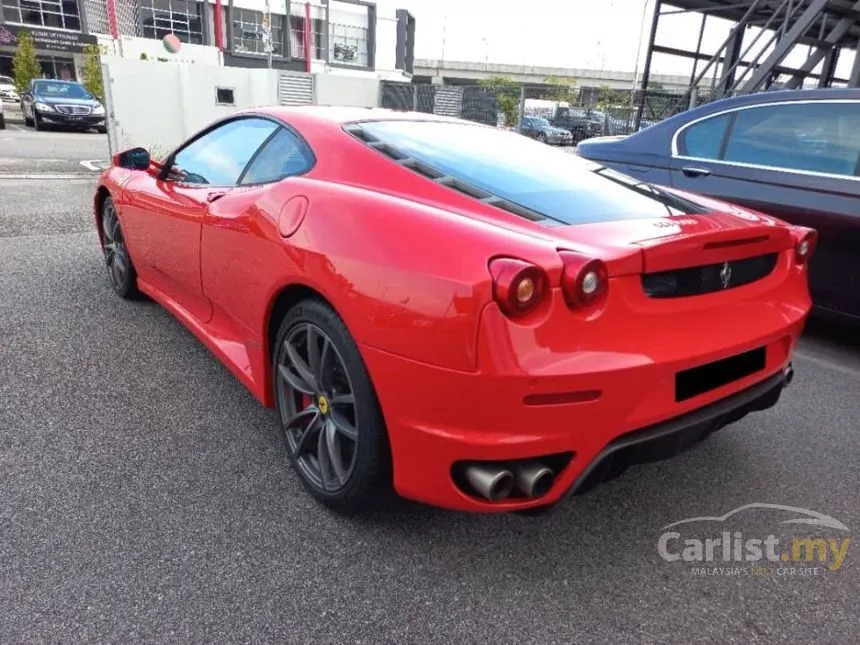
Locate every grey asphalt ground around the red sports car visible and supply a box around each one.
[0,129,860,645]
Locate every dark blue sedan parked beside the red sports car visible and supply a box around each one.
[577,89,860,321]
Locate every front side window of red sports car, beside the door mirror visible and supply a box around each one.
[170,118,279,186]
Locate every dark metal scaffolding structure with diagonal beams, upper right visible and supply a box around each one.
[636,0,860,127]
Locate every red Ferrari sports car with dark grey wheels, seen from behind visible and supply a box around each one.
[94,107,816,512]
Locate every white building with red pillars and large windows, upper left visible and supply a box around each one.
[0,0,415,80]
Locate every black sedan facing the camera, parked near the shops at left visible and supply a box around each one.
[21,79,106,132]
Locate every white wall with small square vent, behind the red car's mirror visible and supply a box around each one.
[102,57,278,157]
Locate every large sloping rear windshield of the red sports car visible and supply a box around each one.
[352,121,707,224]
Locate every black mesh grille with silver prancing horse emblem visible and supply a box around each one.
[642,253,779,298]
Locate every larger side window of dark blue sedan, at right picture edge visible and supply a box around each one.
[725,102,860,176]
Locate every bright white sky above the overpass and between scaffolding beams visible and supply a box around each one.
[386,0,853,78]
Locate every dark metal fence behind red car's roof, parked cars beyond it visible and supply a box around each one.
[380,81,711,141]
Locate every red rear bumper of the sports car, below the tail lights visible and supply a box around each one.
[361,255,811,512]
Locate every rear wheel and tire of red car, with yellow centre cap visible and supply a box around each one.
[272,299,393,514]
